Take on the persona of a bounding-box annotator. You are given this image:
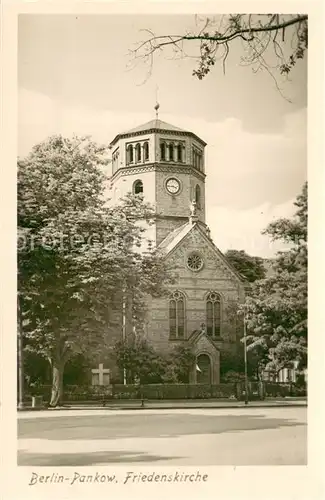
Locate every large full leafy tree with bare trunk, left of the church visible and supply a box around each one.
[18,136,168,406]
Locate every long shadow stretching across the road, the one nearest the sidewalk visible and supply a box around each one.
[18,414,306,440]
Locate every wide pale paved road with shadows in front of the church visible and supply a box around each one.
[18,407,307,466]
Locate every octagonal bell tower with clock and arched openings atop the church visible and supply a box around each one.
[110,113,206,245]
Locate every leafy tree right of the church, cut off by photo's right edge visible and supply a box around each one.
[243,183,307,373]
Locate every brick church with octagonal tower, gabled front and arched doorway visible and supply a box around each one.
[106,116,245,384]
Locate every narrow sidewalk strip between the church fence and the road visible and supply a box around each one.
[19,398,307,411]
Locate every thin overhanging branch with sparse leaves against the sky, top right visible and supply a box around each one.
[131,14,308,98]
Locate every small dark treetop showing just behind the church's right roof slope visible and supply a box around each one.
[225,250,265,283]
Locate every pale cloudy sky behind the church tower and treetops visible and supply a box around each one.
[18,15,307,257]
